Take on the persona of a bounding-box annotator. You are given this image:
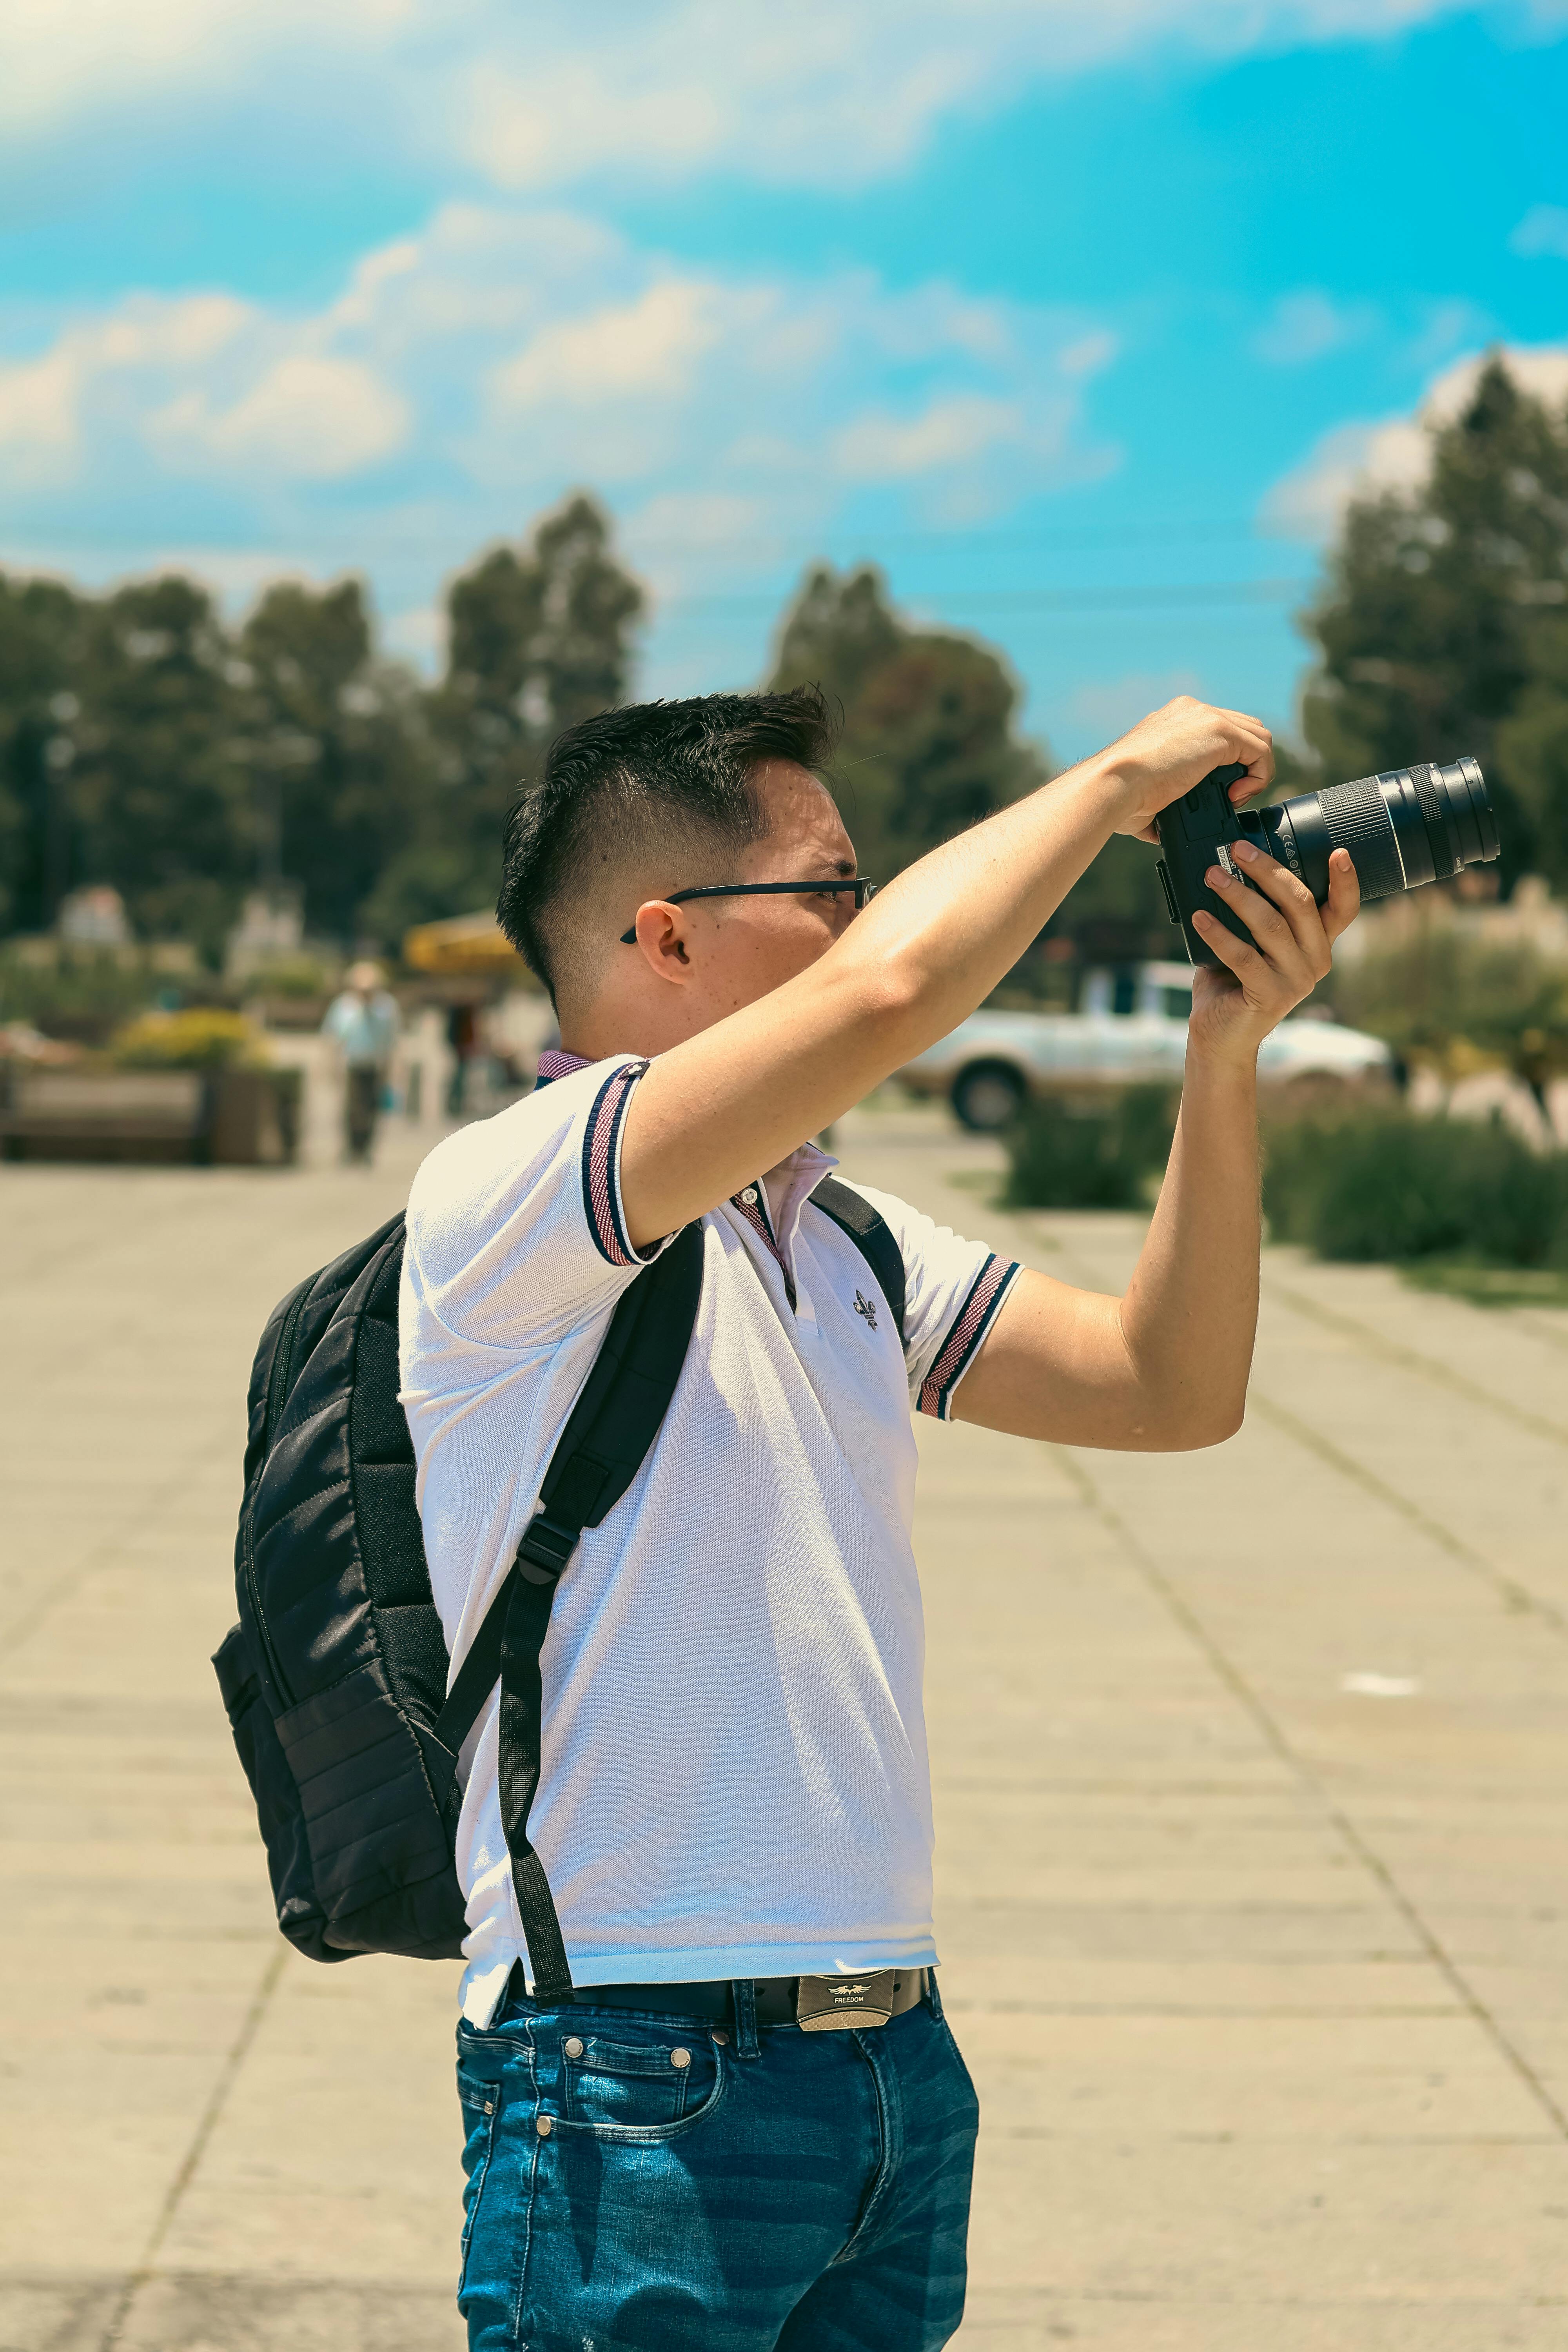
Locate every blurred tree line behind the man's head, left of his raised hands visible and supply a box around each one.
[0,496,1046,960]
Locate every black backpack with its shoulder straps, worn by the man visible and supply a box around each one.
[212,1178,905,1999]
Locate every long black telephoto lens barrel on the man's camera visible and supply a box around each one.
[1248,757,1497,906]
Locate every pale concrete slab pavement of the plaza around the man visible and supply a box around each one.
[0,1091,1568,2352]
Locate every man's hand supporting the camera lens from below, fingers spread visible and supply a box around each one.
[1189,842,1361,1061]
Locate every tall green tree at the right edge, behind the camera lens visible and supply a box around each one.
[1305,358,1568,887]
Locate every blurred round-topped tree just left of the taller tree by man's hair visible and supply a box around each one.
[240,581,435,938]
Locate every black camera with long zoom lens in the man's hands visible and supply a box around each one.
[1157,757,1497,971]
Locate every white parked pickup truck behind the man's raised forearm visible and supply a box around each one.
[896,964,1399,1134]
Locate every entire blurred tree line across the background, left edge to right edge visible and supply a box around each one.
[0,360,1568,960]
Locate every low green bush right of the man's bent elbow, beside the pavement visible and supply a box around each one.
[1262,1112,1568,1265]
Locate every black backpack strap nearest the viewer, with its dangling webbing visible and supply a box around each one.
[435,1225,703,2002]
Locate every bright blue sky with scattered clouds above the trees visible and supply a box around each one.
[0,0,1568,757]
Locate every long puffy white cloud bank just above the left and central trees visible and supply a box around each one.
[0,202,1117,574]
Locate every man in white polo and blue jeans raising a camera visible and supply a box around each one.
[402,689,1356,2352]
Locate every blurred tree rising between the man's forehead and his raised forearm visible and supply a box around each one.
[771,564,1051,882]
